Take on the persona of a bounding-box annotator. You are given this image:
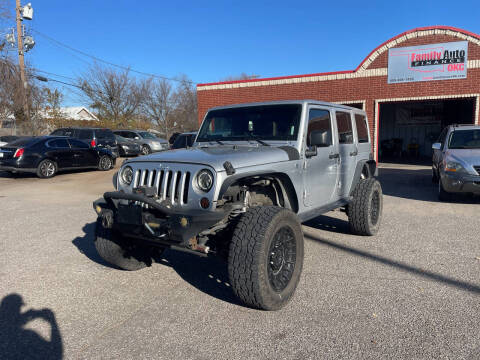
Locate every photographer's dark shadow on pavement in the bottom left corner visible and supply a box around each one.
[0,294,63,360]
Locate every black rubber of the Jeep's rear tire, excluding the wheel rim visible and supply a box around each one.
[348,178,383,236]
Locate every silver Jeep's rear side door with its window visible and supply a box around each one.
[335,110,358,197]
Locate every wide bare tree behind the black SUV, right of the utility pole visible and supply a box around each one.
[78,64,146,126]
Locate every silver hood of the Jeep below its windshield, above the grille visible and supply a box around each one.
[128,145,298,171]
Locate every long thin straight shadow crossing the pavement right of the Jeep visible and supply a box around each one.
[307,235,480,295]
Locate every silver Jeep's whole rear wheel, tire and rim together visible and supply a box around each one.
[348,178,383,236]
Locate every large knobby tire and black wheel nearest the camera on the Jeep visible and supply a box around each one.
[228,206,303,310]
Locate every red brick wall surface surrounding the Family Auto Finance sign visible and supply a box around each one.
[197,27,480,152]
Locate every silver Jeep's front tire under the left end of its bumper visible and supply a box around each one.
[95,218,163,271]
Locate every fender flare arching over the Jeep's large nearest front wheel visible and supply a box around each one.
[218,170,298,213]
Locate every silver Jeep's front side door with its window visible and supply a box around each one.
[303,106,339,207]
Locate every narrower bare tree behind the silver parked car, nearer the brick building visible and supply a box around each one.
[143,79,178,139]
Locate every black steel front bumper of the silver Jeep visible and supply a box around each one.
[93,191,229,248]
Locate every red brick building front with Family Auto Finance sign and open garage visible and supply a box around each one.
[197,26,480,161]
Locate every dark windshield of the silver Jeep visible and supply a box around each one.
[197,104,302,142]
